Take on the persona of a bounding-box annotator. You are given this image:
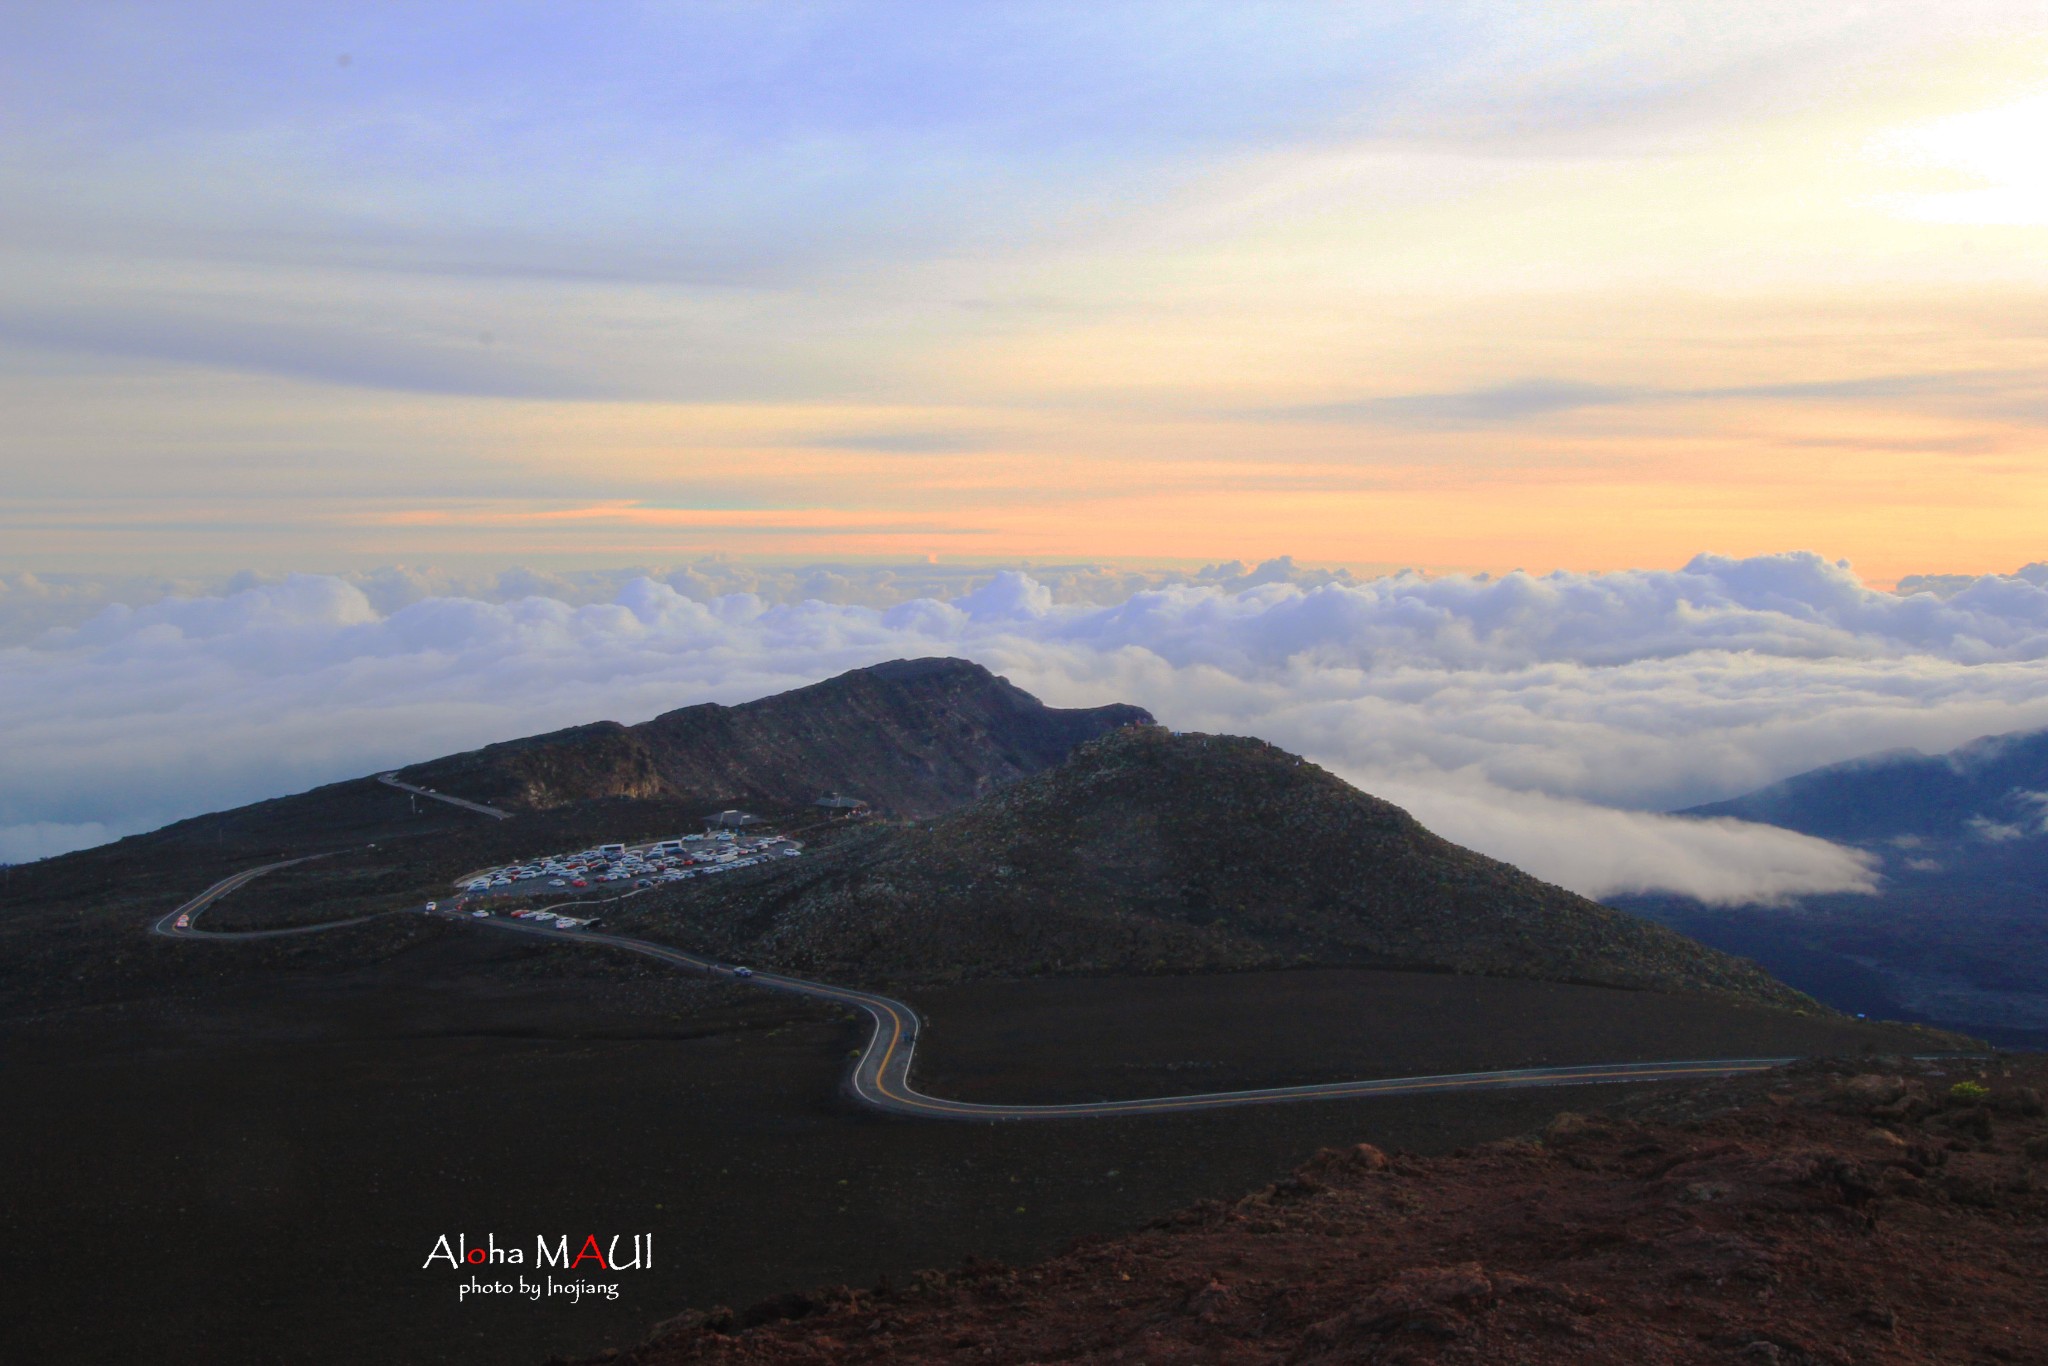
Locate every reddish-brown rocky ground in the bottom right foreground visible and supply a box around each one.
[569,1059,2048,1366]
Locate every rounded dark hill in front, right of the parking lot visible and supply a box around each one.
[621,725,1812,1010]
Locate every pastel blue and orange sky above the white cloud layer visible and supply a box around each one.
[0,0,2048,584]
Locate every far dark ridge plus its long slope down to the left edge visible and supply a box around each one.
[0,659,1151,1010]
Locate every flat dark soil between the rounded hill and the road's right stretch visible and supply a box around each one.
[909,969,1954,1104]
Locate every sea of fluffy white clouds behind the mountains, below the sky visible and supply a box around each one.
[0,553,2048,901]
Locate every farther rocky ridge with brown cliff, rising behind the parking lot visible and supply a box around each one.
[401,659,1151,817]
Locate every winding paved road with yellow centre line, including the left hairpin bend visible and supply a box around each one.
[152,854,1794,1122]
